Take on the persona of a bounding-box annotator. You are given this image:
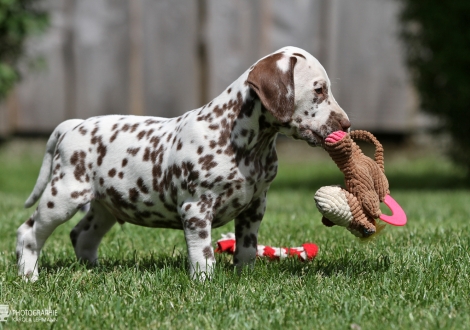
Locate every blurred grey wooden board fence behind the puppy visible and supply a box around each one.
[0,0,417,135]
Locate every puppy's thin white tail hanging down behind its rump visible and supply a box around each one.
[24,119,83,208]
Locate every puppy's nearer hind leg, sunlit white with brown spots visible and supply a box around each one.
[16,181,91,281]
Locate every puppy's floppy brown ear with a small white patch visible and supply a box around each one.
[247,53,297,123]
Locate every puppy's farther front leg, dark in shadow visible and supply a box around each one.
[233,193,266,273]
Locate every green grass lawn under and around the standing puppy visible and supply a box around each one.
[0,141,470,329]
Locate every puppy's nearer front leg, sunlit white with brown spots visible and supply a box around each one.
[180,203,215,280]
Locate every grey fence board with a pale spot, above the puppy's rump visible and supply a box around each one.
[70,0,129,118]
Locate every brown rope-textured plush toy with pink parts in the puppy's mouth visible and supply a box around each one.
[314,130,407,238]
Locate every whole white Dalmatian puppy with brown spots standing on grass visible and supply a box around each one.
[16,47,350,280]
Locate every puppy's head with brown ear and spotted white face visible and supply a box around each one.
[247,47,351,146]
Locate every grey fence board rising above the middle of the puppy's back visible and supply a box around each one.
[143,0,202,117]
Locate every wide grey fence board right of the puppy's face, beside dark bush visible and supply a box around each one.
[327,0,414,131]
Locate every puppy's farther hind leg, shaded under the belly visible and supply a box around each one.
[70,200,116,264]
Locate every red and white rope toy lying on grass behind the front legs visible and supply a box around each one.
[215,233,318,261]
